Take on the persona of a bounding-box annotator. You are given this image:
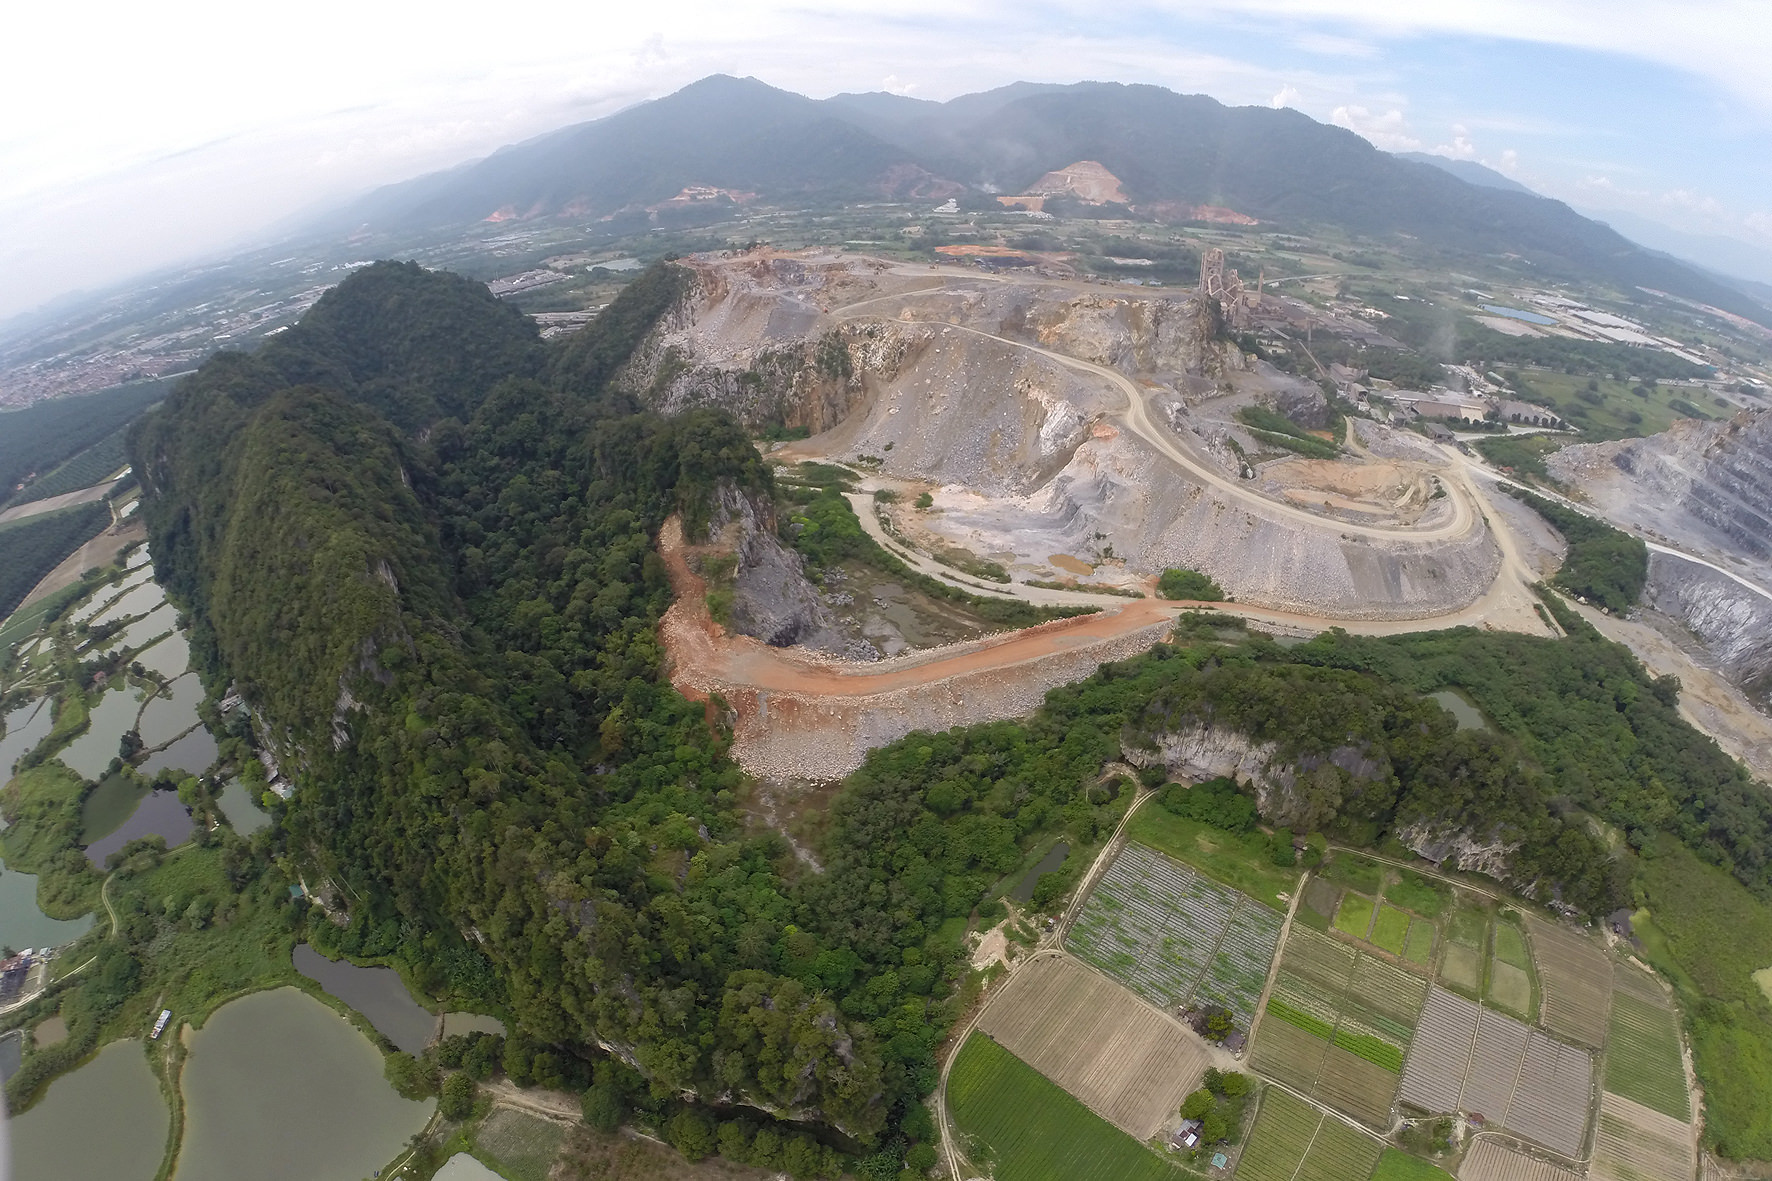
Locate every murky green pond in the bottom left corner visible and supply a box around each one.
[11,1041,167,1181]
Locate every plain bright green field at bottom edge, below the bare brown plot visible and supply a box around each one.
[948,1034,1182,1181]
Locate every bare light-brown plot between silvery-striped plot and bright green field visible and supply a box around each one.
[978,956,1209,1140]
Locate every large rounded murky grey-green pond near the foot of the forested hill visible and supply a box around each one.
[177,988,432,1181]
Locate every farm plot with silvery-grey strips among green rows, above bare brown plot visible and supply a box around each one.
[1067,844,1281,1027]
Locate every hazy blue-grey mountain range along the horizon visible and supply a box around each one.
[326,76,1772,321]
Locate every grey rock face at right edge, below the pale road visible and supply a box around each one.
[1643,550,1772,709]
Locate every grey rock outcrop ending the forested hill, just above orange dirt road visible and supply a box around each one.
[711,488,849,654]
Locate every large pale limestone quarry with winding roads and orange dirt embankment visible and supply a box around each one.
[637,250,1554,778]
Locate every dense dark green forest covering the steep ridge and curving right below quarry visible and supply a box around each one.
[131,253,1772,1176]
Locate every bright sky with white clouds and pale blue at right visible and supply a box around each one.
[0,0,1772,317]
